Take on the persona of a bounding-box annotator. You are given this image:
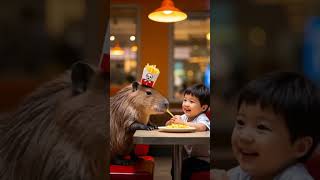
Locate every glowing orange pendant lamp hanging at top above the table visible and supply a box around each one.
[148,0,187,23]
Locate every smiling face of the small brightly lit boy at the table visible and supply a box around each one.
[182,94,205,117]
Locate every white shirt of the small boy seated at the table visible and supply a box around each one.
[181,113,210,162]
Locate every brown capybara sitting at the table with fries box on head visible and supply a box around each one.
[110,82,169,165]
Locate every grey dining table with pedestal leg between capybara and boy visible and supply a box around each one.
[133,129,210,180]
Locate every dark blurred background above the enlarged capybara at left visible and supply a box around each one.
[0,0,109,114]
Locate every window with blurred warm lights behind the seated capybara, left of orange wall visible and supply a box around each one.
[110,5,139,87]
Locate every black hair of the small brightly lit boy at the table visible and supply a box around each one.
[183,84,210,112]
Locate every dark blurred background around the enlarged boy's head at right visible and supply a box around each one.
[211,0,320,169]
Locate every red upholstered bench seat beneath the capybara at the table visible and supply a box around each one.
[110,145,155,180]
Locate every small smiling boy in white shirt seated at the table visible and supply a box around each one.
[166,84,210,180]
